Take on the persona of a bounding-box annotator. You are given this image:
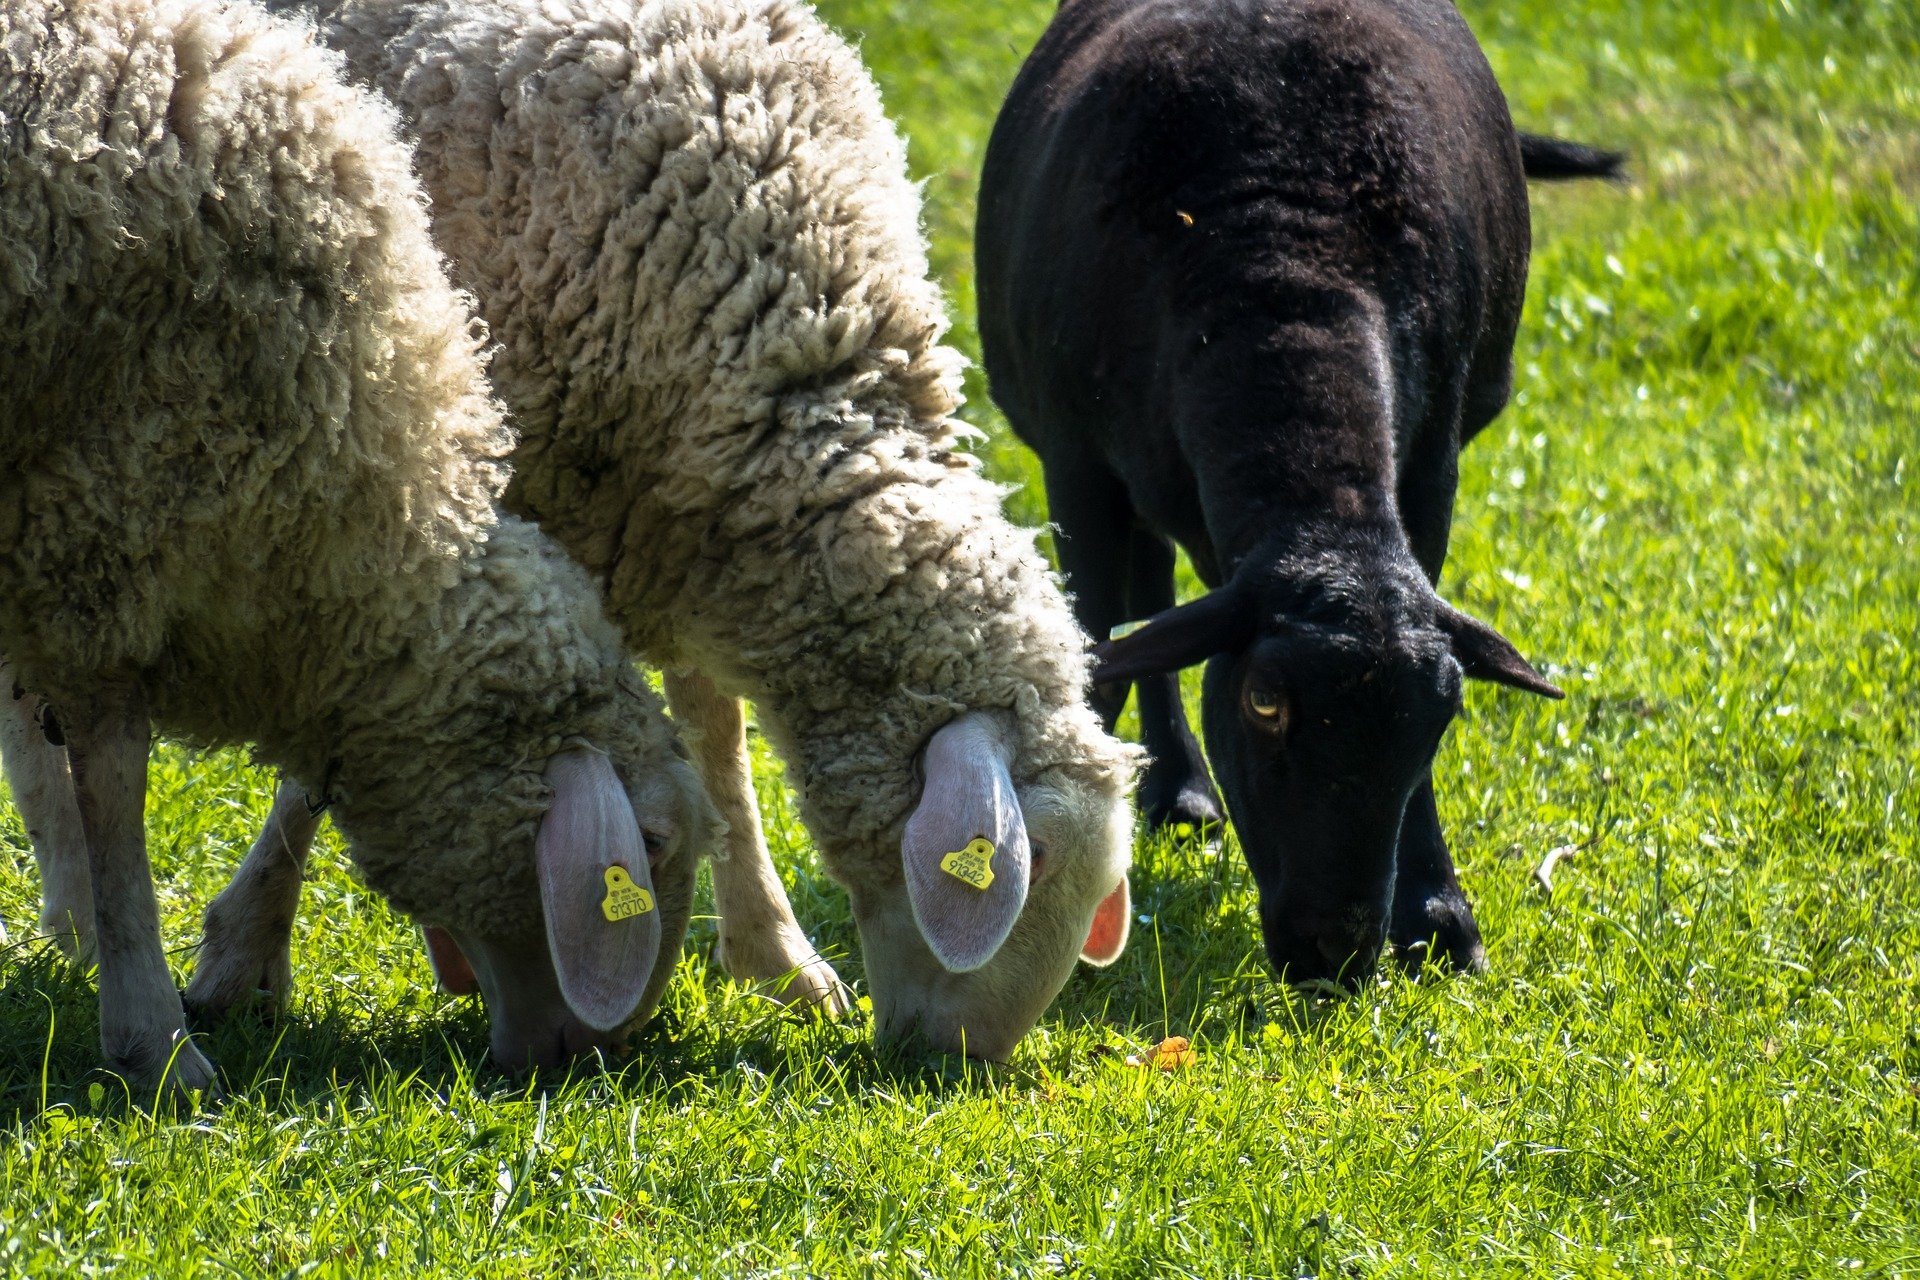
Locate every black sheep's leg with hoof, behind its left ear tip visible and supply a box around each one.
[1127,528,1225,831]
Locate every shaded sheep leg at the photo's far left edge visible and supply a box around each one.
[0,662,94,965]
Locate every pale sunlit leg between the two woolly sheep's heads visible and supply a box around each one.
[666,672,852,1015]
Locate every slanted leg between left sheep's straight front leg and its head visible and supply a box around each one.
[186,779,324,1023]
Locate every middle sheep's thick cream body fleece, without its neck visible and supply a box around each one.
[303,0,960,637]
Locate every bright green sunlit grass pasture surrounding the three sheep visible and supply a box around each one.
[0,0,1920,1280]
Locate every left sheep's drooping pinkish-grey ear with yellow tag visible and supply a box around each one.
[534,748,660,1031]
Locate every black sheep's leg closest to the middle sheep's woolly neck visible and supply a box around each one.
[1046,461,1133,733]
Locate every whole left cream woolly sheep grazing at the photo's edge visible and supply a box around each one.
[0,0,710,1088]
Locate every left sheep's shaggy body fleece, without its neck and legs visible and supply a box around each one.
[0,0,511,739]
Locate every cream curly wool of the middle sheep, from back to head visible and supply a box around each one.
[282,0,1137,883]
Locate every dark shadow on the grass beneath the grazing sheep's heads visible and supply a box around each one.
[0,821,1428,1126]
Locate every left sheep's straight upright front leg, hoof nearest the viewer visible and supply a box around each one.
[60,683,213,1090]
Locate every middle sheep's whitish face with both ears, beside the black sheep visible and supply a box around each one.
[852,716,1133,1059]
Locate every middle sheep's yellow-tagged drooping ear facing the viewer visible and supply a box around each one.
[900,712,1033,973]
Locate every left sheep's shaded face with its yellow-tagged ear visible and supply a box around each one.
[422,748,712,1069]
